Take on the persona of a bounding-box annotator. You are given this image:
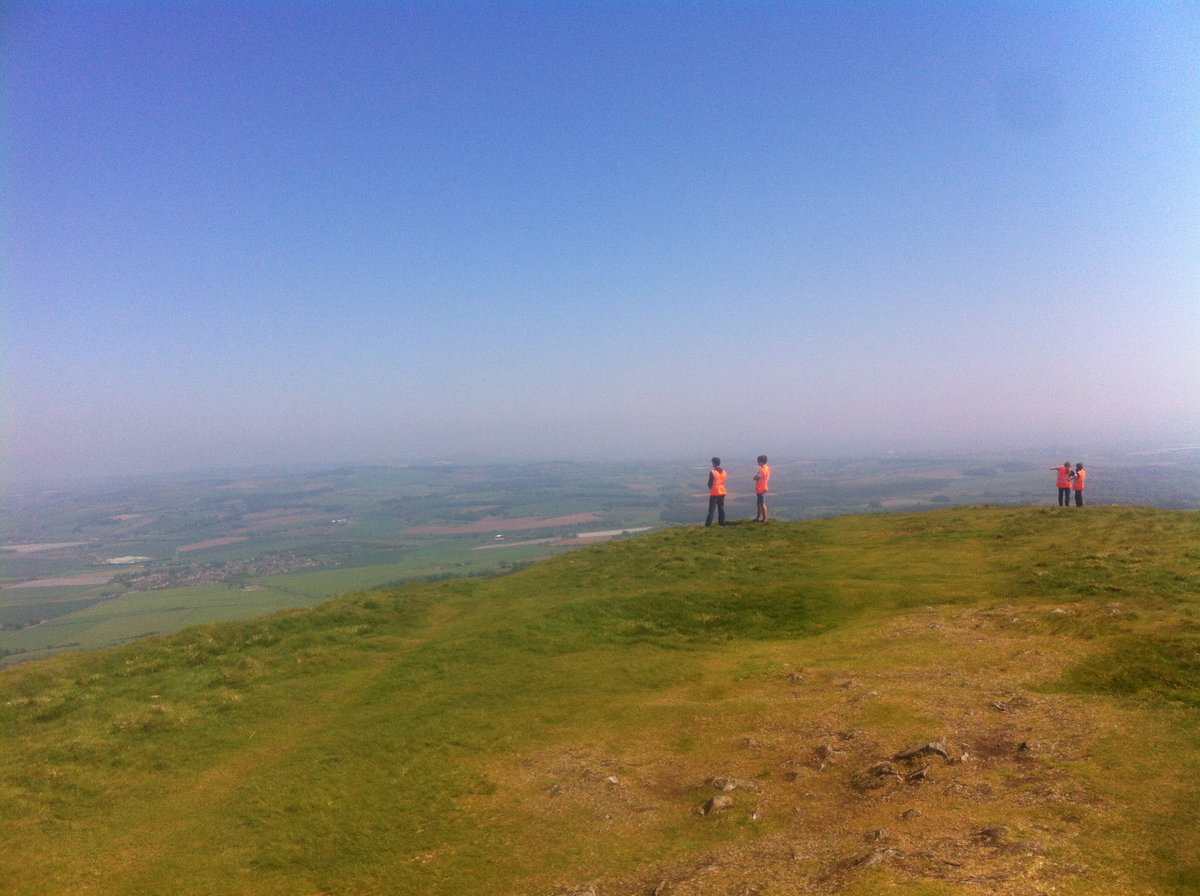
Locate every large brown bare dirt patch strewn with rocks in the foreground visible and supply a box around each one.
[490,611,1138,896]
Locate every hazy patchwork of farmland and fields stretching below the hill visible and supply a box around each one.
[0,450,1200,665]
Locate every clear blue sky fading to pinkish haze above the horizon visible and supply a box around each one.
[0,0,1200,479]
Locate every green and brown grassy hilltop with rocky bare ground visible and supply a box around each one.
[0,507,1200,896]
